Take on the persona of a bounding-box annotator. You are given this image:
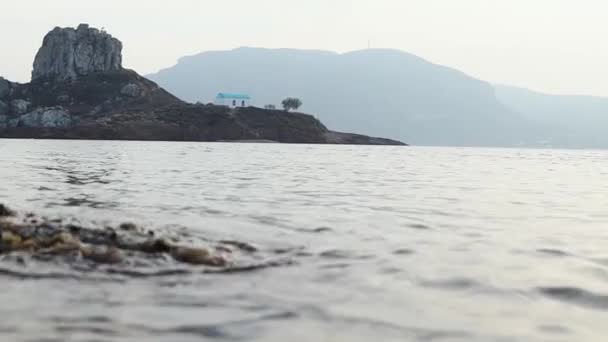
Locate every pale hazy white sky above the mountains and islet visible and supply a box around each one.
[0,0,608,96]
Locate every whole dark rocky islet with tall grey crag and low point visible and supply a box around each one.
[0,24,404,145]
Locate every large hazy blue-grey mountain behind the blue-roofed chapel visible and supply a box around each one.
[148,48,540,146]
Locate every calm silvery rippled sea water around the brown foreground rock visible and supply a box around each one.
[0,140,608,341]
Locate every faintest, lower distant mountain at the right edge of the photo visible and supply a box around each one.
[495,85,608,148]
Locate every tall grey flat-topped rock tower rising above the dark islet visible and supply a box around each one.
[32,24,122,81]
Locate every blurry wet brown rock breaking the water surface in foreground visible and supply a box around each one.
[0,204,231,267]
